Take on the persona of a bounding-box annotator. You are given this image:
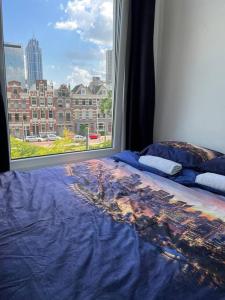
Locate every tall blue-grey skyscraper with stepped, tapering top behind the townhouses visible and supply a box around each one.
[26,38,43,87]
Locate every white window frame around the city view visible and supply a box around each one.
[0,0,129,170]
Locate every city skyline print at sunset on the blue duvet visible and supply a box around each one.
[66,159,225,285]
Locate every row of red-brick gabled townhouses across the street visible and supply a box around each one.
[7,78,112,139]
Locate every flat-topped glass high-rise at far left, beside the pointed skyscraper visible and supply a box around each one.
[4,43,25,87]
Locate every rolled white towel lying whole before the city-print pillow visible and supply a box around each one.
[139,155,182,175]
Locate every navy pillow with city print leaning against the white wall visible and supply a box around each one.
[141,141,223,168]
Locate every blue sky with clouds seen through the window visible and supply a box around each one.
[2,0,113,86]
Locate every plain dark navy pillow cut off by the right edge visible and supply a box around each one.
[200,155,225,175]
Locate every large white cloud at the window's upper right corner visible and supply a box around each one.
[54,0,113,47]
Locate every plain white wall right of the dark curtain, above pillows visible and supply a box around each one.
[154,0,225,152]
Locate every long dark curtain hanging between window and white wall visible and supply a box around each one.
[126,0,155,151]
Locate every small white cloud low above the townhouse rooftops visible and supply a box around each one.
[67,66,92,86]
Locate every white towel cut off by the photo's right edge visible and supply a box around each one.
[195,173,225,192]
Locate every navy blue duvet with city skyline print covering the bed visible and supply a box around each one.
[0,159,225,300]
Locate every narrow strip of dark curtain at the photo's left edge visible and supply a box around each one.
[0,87,10,172]
